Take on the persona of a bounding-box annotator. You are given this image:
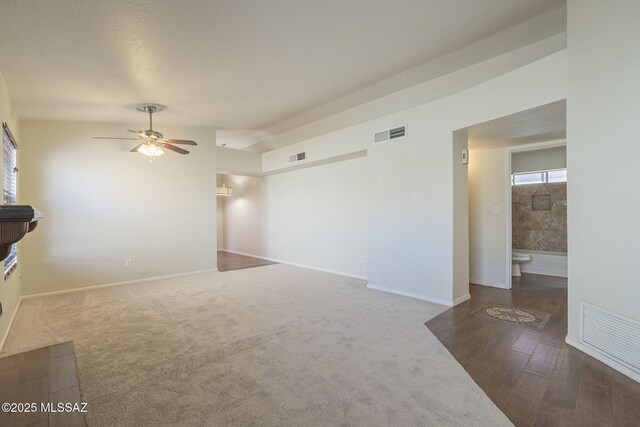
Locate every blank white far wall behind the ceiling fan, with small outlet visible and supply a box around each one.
[20,121,216,294]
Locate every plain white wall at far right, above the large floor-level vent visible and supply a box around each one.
[567,0,640,350]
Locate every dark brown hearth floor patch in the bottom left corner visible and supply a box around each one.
[0,342,89,427]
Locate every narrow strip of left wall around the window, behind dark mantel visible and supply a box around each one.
[0,74,23,349]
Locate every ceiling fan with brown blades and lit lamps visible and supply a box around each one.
[93,104,198,160]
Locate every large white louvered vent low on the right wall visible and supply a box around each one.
[580,302,640,373]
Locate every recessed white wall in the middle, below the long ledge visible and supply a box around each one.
[223,160,367,277]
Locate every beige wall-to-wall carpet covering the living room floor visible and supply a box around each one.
[3,265,511,426]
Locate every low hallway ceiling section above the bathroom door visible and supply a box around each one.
[467,99,567,151]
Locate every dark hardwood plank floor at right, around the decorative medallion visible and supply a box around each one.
[426,273,640,427]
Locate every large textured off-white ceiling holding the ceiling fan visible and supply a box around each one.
[0,0,564,147]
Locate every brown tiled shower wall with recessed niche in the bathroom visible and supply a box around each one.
[511,182,567,253]
